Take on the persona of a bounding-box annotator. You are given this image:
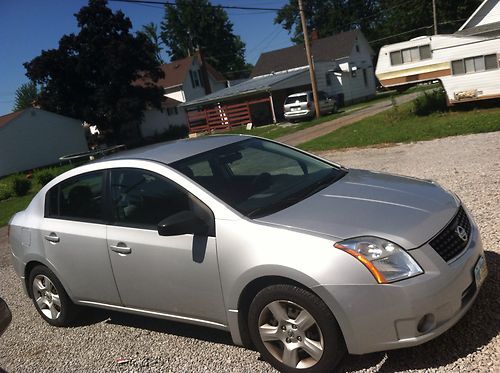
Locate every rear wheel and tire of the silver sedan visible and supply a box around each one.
[29,265,76,326]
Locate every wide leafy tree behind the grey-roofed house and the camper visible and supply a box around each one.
[274,0,481,49]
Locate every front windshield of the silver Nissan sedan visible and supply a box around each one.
[171,138,346,218]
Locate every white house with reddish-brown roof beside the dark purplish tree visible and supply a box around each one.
[141,55,226,137]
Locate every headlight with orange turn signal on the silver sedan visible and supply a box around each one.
[334,237,424,284]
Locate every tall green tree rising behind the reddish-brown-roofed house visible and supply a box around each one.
[161,0,248,79]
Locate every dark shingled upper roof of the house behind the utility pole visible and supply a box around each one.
[250,30,361,78]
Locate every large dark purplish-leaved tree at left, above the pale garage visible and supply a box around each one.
[24,0,163,143]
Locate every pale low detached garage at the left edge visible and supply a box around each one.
[0,108,88,176]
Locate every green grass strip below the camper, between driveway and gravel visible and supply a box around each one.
[299,102,500,151]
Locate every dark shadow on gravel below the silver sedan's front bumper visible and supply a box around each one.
[339,251,500,372]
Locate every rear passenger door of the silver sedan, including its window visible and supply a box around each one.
[39,171,121,305]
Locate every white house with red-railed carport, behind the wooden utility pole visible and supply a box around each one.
[182,30,376,132]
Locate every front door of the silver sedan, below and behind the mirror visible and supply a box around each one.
[107,168,226,324]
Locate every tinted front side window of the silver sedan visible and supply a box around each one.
[111,169,190,229]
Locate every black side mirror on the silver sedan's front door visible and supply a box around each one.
[158,211,209,236]
